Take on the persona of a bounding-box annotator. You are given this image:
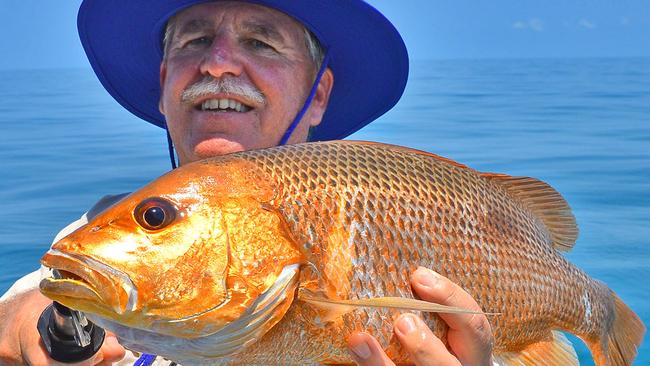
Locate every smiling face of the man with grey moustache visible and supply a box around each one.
[160,2,333,164]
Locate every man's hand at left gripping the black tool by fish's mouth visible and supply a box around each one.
[0,290,125,366]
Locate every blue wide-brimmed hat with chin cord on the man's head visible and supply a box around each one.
[77,0,408,141]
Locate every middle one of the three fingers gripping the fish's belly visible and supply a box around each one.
[395,314,460,366]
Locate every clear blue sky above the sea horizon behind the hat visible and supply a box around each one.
[0,0,650,69]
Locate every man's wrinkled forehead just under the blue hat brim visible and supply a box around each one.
[173,1,303,38]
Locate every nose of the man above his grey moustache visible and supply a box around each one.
[200,37,243,78]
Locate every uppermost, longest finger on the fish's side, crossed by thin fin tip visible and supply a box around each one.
[411,267,494,365]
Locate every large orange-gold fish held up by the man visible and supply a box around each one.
[40,141,645,366]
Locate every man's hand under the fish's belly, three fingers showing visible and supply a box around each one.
[348,267,494,366]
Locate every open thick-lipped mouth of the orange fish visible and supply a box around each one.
[39,249,138,315]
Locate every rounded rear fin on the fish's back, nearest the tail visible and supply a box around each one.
[480,173,578,251]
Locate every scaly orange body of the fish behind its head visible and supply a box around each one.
[214,142,644,365]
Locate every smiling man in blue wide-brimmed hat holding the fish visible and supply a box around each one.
[0,0,492,365]
